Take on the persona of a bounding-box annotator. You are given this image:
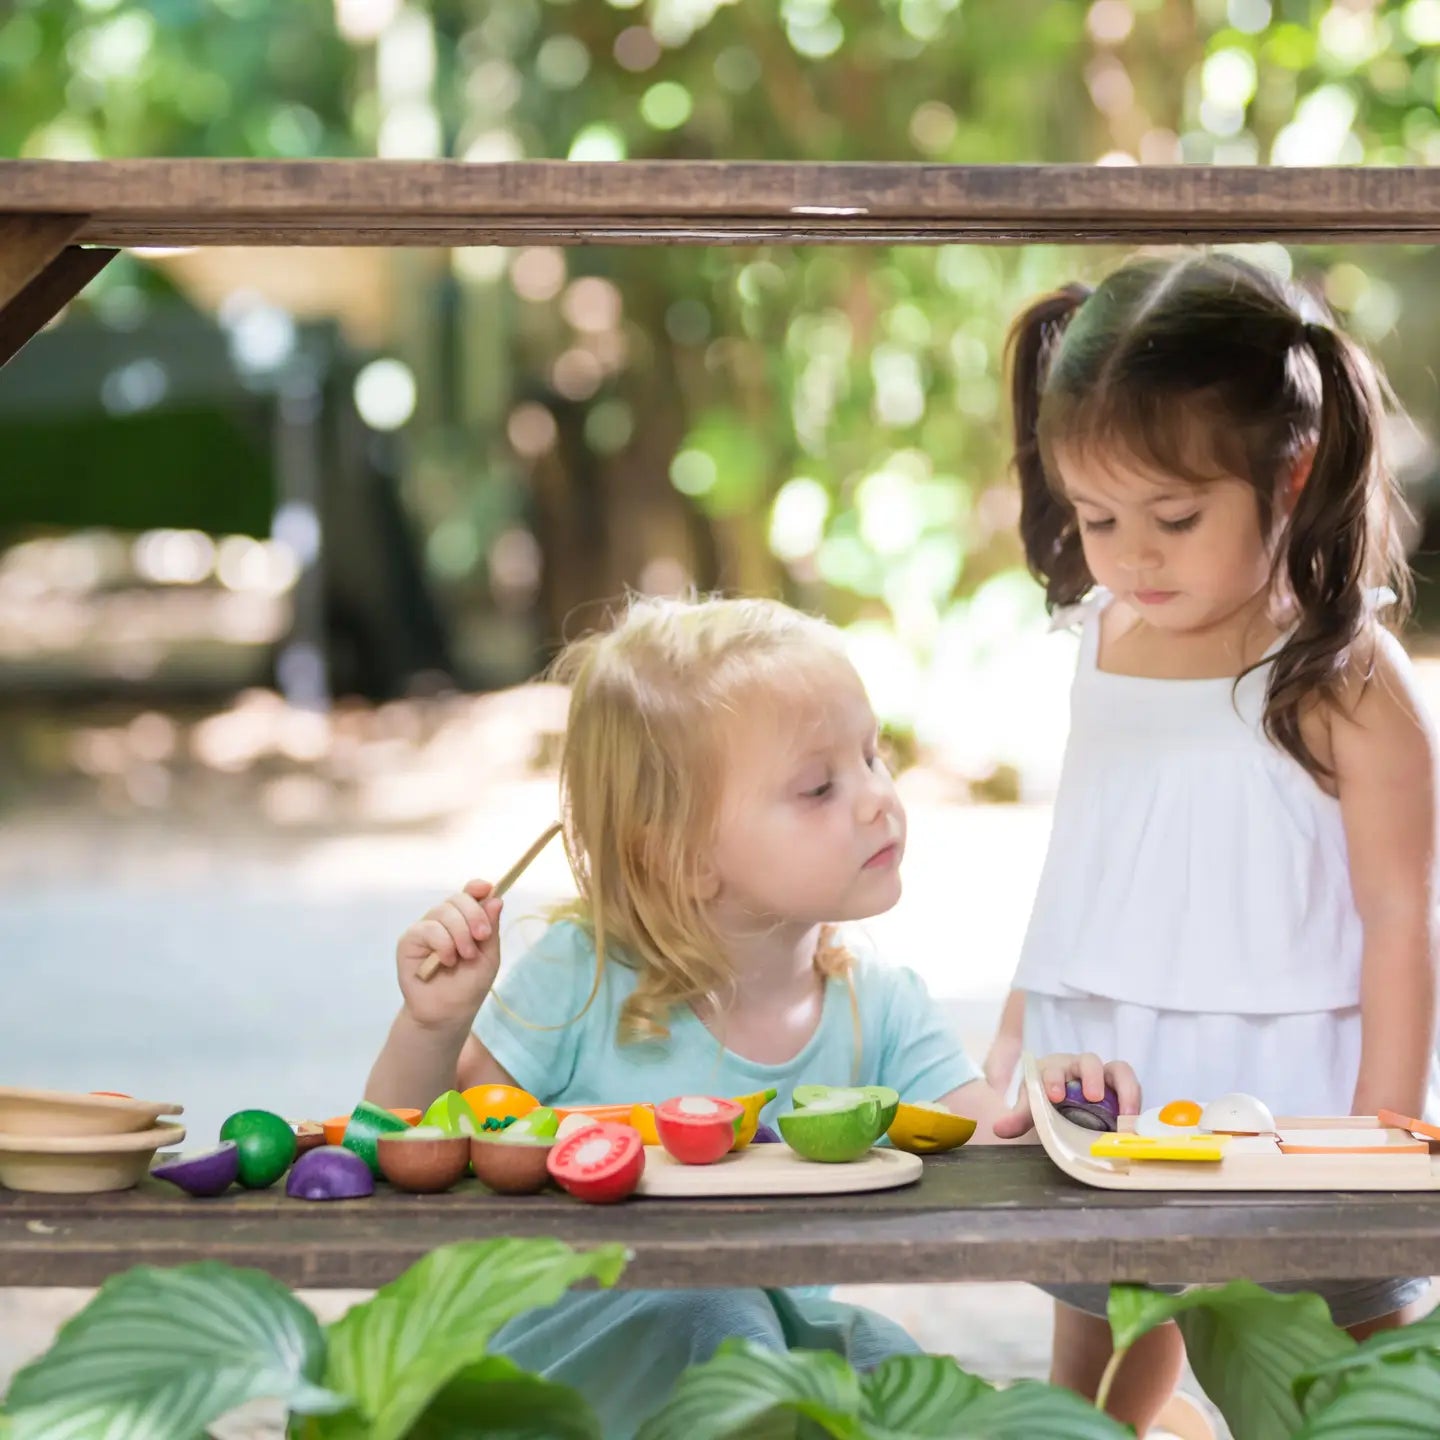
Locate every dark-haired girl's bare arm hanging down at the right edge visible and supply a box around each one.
[1331,634,1436,1115]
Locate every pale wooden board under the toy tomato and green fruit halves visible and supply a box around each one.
[636,1145,924,1200]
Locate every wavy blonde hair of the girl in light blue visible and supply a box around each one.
[552,598,851,1044]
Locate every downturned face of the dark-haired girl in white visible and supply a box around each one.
[1056,451,1273,632]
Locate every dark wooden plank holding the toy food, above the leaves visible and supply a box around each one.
[0,1146,1440,1289]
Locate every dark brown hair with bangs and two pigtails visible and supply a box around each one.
[1008,255,1410,776]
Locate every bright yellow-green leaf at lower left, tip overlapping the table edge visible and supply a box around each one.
[315,1238,626,1440]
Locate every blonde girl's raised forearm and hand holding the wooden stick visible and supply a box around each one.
[364,880,513,1109]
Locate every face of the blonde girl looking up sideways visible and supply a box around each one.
[710,662,906,932]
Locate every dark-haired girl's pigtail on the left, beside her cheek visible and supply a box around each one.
[1005,285,1093,609]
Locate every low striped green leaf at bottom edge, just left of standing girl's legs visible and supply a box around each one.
[860,1355,1132,1440]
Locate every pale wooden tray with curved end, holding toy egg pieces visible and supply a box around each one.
[1024,1056,1440,1191]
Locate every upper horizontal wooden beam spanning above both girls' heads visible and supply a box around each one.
[0,160,1440,245]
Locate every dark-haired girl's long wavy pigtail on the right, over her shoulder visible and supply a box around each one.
[1264,324,1410,779]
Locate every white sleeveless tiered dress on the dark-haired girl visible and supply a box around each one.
[1015,593,1440,1119]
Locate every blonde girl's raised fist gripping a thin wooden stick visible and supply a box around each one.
[395,880,503,1030]
